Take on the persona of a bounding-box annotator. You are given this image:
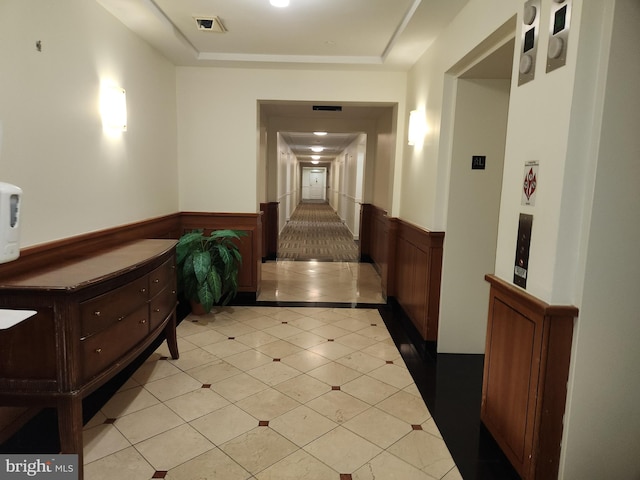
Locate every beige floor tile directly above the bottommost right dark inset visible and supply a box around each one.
[304,427,382,473]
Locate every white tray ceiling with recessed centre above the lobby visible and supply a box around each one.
[97,0,468,70]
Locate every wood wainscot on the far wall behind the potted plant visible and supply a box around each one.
[180,212,262,298]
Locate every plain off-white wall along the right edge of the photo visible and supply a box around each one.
[562,0,640,479]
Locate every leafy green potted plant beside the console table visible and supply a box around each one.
[176,230,247,313]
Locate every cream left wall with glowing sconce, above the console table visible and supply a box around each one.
[0,0,178,248]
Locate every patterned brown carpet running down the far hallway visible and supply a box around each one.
[278,202,359,262]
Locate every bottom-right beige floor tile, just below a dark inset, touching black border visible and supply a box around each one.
[388,430,455,478]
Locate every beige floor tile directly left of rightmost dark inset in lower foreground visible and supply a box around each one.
[343,407,412,449]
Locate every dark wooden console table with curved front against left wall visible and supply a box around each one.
[0,239,178,478]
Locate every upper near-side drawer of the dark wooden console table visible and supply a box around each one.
[80,275,149,338]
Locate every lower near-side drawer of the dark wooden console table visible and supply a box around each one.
[80,304,149,380]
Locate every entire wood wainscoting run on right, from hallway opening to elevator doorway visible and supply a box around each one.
[360,204,444,342]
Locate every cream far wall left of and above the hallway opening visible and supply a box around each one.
[177,67,406,213]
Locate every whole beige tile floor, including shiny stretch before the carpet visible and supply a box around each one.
[84,262,462,480]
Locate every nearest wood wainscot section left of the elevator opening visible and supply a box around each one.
[391,220,444,342]
